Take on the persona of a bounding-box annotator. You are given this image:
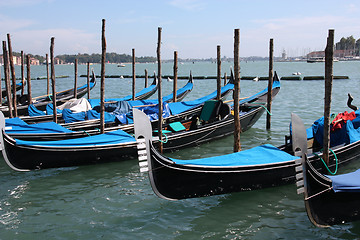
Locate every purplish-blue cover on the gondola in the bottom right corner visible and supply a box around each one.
[326,169,360,192]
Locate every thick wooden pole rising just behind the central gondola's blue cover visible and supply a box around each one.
[234,29,241,152]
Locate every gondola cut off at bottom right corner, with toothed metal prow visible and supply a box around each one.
[294,113,360,227]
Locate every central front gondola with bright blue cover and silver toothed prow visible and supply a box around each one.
[134,101,360,200]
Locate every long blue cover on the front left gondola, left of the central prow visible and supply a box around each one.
[16,130,135,147]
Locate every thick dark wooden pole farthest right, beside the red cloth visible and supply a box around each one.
[323,29,334,165]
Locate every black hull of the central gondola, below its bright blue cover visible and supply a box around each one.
[149,145,294,200]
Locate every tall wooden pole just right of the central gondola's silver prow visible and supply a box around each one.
[156,27,163,153]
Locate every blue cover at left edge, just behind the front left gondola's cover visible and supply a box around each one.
[5,118,72,134]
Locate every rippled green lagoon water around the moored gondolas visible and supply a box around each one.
[0,62,360,239]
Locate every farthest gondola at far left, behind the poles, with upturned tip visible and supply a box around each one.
[0,72,96,116]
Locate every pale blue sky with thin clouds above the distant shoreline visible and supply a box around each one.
[0,0,360,59]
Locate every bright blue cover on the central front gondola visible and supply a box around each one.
[171,144,299,167]
